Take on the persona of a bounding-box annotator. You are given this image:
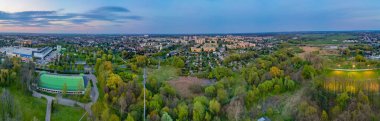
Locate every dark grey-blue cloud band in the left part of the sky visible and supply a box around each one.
[0,6,142,27]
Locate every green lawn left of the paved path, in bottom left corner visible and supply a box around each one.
[1,88,46,121]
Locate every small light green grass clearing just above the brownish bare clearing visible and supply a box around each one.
[148,66,179,81]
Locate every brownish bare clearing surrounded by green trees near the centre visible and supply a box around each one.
[169,77,212,98]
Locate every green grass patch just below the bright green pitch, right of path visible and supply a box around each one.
[51,104,87,121]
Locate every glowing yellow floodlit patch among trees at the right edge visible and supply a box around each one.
[324,69,380,93]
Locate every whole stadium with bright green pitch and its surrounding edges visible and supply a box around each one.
[37,73,88,94]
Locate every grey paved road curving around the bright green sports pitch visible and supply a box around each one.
[33,74,99,121]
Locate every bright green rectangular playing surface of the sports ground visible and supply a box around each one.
[39,74,85,91]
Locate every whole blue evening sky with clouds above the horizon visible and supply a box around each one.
[0,0,380,34]
